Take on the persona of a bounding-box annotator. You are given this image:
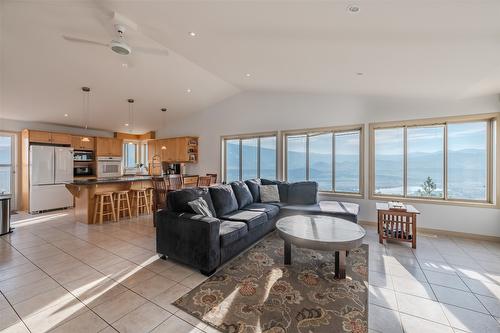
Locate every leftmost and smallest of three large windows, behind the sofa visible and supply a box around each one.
[222,133,278,183]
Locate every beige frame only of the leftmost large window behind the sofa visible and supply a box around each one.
[220,131,280,183]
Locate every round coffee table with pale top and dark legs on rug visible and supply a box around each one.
[276,215,366,279]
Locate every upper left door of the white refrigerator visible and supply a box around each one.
[30,146,54,185]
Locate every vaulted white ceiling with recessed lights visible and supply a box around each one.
[0,0,500,132]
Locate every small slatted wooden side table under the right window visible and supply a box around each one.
[377,202,420,249]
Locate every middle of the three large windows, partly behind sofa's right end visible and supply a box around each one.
[283,126,363,194]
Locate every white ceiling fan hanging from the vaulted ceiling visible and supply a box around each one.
[62,12,168,56]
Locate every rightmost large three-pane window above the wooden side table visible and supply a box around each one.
[371,117,496,203]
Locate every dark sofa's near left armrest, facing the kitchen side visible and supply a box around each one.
[156,211,220,272]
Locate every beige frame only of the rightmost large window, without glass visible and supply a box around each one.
[368,113,500,208]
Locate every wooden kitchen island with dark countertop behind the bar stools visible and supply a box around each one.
[66,176,152,224]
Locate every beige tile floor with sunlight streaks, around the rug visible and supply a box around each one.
[0,210,500,333]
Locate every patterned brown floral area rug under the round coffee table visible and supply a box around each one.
[174,233,368,333]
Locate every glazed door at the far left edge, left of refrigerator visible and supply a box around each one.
[0,133,16,197]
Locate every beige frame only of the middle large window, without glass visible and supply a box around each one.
[281,124,365,198]
